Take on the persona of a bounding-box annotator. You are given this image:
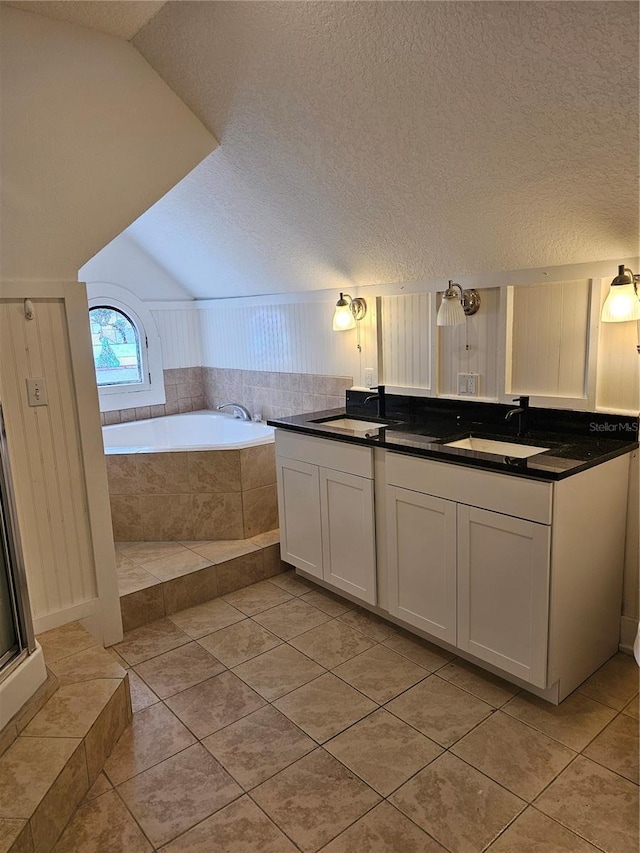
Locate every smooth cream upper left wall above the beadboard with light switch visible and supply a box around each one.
[0,6,216,281]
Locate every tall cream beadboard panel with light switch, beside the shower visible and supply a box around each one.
[0,299,97,620]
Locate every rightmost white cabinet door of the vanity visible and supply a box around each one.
[458,505,550,687]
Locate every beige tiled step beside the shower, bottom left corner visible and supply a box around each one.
[0,623,131,853]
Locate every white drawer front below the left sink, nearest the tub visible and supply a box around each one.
[276,429,373,479]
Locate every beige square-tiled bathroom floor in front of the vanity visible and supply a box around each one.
[55,573,638,853]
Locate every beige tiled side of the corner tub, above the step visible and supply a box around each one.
[106,444,278,541]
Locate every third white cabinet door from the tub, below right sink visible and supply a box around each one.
[387,486,456,644]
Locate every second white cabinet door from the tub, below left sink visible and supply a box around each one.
[320,468,376,604]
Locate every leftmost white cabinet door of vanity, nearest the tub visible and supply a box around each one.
[277,456,322,578]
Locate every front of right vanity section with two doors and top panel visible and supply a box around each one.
[386,453,552,688]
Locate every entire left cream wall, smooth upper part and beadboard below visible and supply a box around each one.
[0,5,216,643]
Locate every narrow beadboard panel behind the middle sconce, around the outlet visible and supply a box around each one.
[438,287,500,399]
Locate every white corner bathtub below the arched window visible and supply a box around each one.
[102,411,274,455]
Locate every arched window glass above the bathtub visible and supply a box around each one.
[89,305,143,388]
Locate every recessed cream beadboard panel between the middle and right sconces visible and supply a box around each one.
[509,280,590,398]
